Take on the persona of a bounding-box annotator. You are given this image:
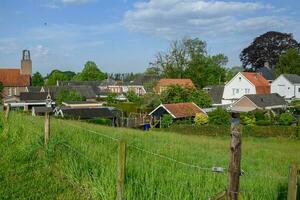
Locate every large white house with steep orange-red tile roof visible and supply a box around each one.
[222,72,271,105]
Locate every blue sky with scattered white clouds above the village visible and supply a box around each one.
[0,0,300,74]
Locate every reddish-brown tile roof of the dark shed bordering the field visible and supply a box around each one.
[163,103,206,118]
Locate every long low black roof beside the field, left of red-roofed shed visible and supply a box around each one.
[61,107,115,119]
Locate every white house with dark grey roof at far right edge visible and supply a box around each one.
[271,74,300,100]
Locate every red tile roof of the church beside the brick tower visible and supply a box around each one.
[0,69,30,87]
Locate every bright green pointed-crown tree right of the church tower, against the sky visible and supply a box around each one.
[73,61,107,81]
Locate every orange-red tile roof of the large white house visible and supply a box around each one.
[242,72,271,94]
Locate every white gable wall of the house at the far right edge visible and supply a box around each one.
[271,75,294,99]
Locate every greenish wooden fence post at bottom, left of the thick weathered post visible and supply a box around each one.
[117,140,126,200]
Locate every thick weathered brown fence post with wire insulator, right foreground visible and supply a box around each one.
[227,124,242,200]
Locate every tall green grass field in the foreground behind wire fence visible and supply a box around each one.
[0,112,300,200]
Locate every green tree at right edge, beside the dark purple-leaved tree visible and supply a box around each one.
[275,49,300,76]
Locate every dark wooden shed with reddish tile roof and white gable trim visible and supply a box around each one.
[149,102,206,124]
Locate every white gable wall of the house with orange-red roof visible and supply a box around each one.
[222,73,256,104]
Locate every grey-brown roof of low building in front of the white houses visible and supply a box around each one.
[245,93,286,108]
